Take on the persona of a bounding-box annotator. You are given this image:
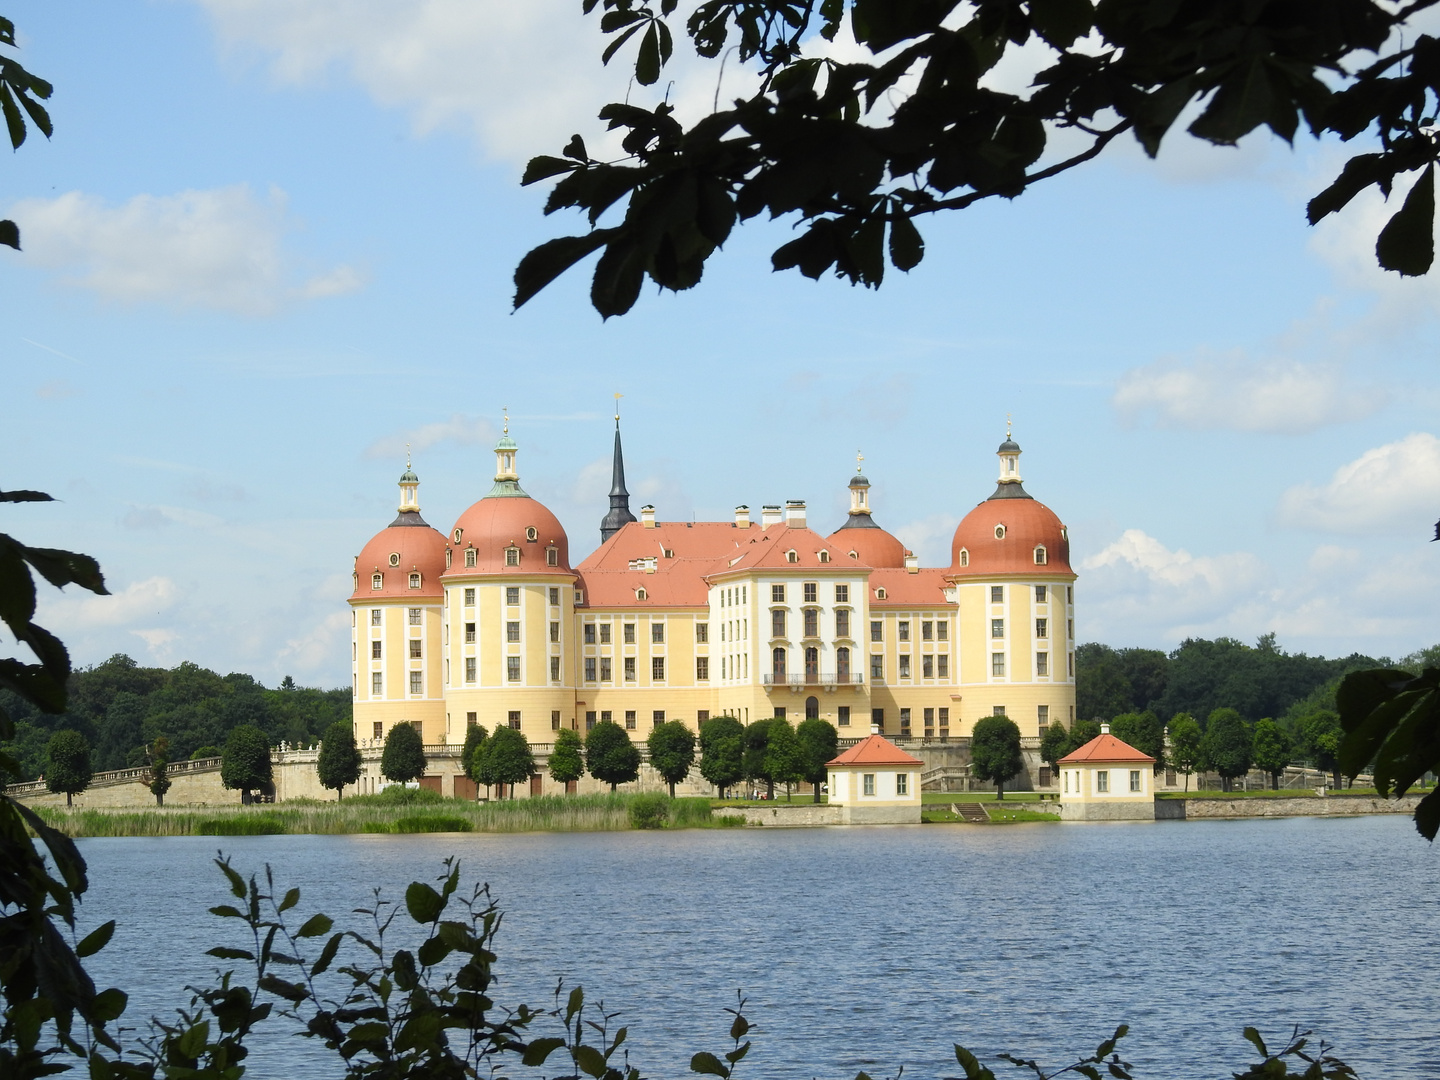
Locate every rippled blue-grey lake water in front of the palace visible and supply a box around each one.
[81,816,1440,1080]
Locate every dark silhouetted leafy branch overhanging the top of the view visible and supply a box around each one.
[514,0,1440,318]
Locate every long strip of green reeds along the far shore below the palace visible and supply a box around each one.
[36,792,730,837]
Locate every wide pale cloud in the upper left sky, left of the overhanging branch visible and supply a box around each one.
[9,184,361,315]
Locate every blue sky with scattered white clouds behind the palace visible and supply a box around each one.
[0,0,1440,685]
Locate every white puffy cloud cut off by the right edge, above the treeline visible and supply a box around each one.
[1279,432,1440,533]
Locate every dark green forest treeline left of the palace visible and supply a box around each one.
[0,654,351,779]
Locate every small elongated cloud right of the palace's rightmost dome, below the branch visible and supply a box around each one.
[1110,353,1385,435]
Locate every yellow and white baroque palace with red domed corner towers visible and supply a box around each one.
[350,418,1076,744]
